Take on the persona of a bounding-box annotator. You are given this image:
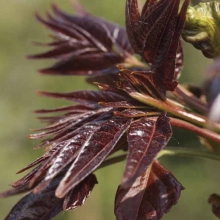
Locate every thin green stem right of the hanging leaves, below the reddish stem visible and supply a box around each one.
[158,147,220,161]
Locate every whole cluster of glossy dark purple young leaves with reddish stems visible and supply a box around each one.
[0,0,220,220]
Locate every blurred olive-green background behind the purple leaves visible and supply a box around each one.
[0,0,217,220]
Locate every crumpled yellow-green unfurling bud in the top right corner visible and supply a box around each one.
[182,1,220,58]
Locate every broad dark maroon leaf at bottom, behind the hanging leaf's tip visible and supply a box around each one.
[115,161,183,220]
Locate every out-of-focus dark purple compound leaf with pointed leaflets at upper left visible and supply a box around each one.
[29,5,133,75]
